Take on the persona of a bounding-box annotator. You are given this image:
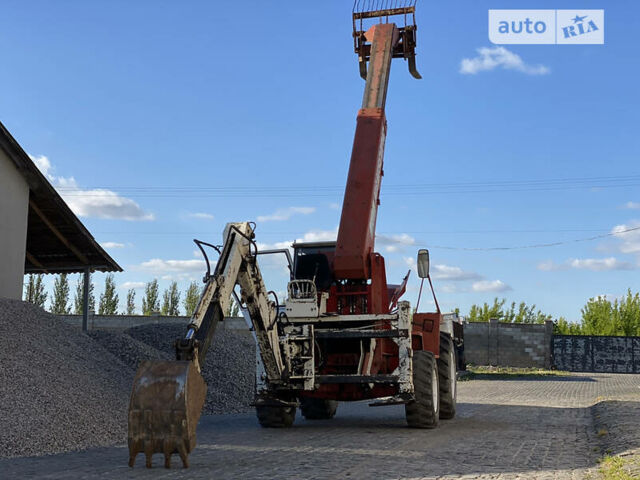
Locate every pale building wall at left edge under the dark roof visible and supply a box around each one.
[0,150,29,299]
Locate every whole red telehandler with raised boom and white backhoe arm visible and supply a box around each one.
[129,1,461,467]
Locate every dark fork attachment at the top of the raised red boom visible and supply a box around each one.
[353,0,422,80]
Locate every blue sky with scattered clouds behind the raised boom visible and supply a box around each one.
[0,0,640,320]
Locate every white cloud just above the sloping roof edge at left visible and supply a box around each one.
[29,155,155,220]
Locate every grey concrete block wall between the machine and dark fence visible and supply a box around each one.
[464,320,553,368]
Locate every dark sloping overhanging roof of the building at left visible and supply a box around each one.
[0,122,122,273]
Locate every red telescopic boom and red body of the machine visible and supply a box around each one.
[294,23,441,400]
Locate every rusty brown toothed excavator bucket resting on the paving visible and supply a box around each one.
[128,360,207,468]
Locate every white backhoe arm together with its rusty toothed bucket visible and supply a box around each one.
[128,222,286,467]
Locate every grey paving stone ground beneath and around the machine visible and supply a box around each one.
[0,374,640,480]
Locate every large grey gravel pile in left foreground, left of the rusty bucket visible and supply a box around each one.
[0,299,134,457]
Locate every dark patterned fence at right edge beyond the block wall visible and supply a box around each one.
[553,335,640,373]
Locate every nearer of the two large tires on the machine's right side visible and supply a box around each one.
[404,350,440,428]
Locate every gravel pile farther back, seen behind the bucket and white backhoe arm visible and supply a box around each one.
[125,323,256,414]
